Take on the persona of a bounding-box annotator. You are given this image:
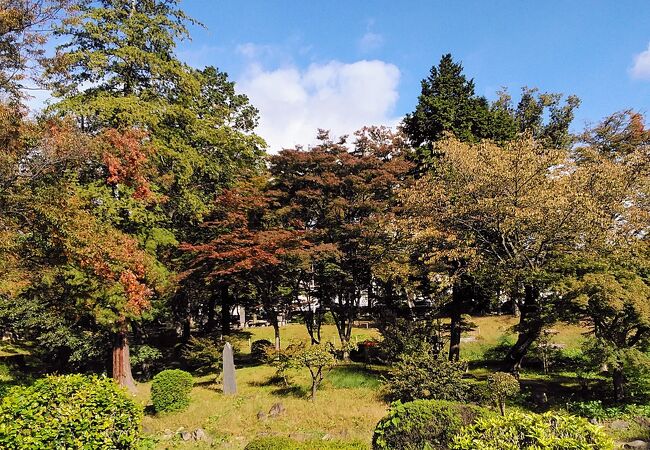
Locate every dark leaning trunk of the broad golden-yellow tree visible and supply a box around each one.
[505,285,544,375]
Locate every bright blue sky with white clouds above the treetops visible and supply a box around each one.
[43,0,650,150]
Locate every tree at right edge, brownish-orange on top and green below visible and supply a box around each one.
[565,111,650,401]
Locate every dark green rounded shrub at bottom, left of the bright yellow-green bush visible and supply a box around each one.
[372,400,489,450]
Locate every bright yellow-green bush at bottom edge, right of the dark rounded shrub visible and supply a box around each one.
[450,412,614,450]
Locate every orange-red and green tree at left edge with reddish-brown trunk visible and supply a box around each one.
[0,105,164,388]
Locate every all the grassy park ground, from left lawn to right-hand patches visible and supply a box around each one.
[115,316,650,449]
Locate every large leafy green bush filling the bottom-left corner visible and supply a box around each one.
[0,375,142,449]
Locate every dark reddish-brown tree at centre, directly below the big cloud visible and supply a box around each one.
[270,128,412,352]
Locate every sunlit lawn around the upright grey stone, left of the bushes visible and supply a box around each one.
[138,324,388,449]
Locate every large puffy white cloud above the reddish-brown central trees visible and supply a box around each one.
[237,60,400,152]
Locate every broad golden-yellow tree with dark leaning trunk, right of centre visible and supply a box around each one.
[404,138,615,371]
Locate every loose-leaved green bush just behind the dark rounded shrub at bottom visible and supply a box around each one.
[385,353,468,402]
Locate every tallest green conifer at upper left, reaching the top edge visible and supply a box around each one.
[45,0,264,384]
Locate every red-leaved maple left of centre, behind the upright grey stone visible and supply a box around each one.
[181,179,309,348]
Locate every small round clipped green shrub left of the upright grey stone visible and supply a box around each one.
[151,369,194,412]
